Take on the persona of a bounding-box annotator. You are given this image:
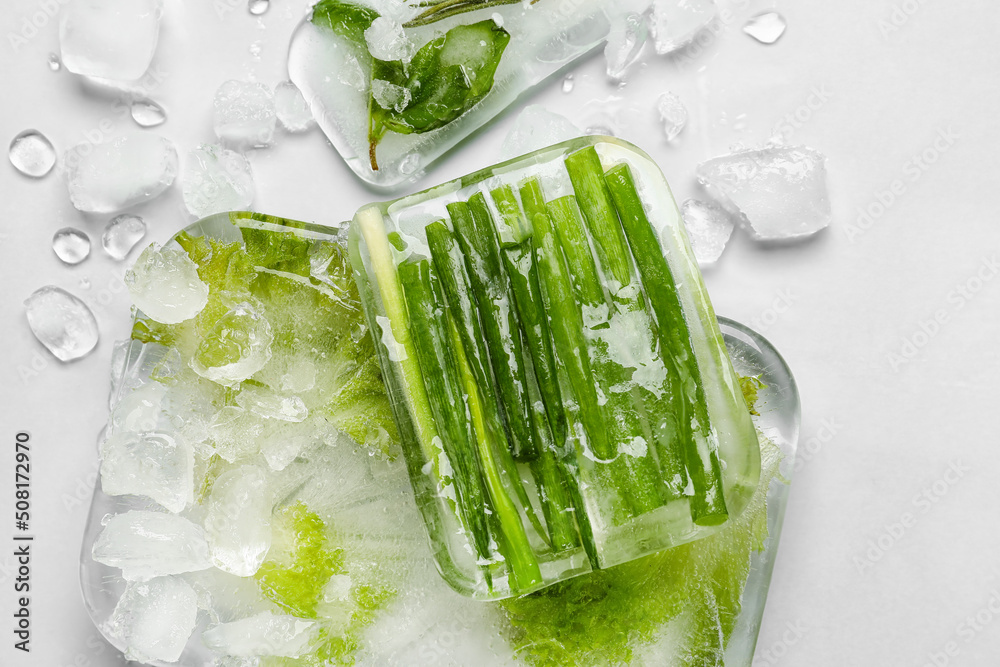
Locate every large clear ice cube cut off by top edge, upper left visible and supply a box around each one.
[59,0,163,81]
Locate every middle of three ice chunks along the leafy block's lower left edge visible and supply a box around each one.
[93,510,212,581]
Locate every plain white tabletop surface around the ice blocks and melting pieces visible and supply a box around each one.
[0,0,1000,667]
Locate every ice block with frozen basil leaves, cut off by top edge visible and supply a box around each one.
[288,0,610,188]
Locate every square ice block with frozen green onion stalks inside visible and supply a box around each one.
[350,137,760,599]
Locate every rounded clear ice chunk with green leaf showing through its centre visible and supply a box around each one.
[191,301,274,386]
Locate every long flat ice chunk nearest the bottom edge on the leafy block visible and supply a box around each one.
[201,611,319,658]
